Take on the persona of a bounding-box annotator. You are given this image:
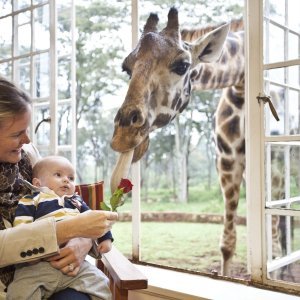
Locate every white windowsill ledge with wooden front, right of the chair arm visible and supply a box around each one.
[129,265,300,300]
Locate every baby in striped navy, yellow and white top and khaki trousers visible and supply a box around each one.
[7,156,112,300]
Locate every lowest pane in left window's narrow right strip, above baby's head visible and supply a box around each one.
[58,104,72,145]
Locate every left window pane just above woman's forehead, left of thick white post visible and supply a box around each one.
[34,53,50,98]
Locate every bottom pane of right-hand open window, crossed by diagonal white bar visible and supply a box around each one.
[266,215,300,283]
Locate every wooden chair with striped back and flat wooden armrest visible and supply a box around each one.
[76,181,148,300]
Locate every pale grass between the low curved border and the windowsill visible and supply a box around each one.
[113,222,246,277]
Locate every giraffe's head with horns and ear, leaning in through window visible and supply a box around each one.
[111,8,229,162]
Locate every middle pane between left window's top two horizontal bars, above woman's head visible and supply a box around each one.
[15,11,31,55]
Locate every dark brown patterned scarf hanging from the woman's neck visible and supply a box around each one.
[0,150,32,286]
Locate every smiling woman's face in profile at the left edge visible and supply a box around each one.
[0,107,31,163]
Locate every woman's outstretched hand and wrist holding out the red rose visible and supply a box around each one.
[56,210,118,245]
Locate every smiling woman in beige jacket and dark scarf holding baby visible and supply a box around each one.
[0,78,117,299]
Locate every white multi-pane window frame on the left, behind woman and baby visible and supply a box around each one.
[1,0,76,168]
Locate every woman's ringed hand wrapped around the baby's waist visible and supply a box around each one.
[47,238,92,277]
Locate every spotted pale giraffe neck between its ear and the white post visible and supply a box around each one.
[191,32,245,90]
